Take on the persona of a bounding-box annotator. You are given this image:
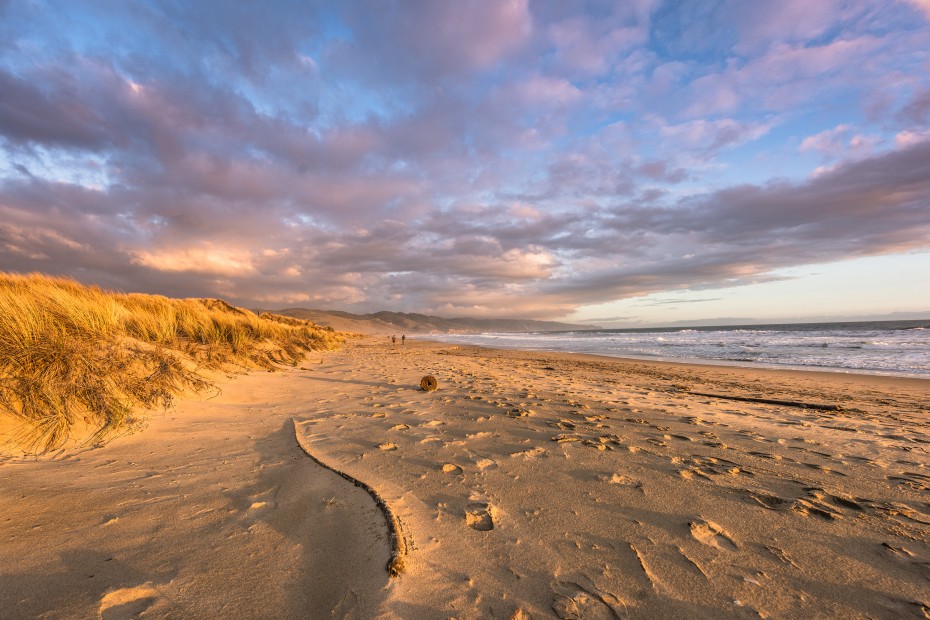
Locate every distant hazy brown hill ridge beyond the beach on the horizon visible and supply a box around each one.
[275,308,597,333]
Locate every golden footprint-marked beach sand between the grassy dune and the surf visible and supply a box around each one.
[0,337,930,618]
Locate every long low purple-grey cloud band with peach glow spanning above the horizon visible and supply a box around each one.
[0,142,930,316]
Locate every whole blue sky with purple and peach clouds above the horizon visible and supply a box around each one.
[0,0,930,325]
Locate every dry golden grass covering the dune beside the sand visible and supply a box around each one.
[0,272,342,451]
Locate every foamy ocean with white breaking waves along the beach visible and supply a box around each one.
[425,320,930,379]
